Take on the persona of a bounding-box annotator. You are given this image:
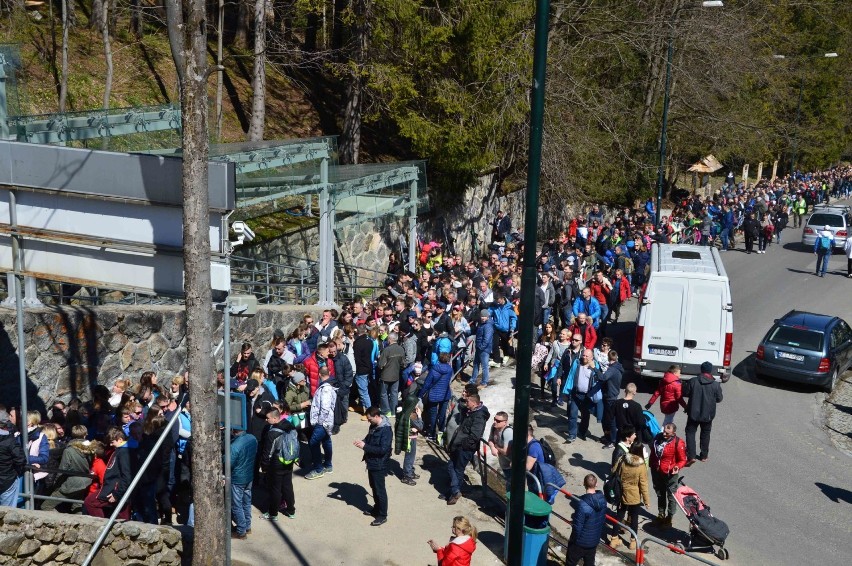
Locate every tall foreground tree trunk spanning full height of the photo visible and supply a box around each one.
[167,0,223,566]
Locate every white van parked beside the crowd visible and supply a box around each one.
[633,244,734,381]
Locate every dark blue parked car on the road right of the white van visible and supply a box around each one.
[755,310,852,392]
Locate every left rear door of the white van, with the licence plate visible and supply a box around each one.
[642,277,688,363]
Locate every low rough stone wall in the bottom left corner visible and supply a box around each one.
[0,507,183,566]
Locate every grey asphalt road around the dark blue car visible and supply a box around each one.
[640,224,852,565]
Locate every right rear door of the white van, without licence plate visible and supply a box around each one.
[681,279,727,366]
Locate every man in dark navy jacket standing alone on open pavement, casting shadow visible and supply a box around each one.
[353,407,393,527]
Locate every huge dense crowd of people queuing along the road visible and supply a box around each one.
[0,168,852,563]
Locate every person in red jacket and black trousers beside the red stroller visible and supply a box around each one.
[651,423,686,527]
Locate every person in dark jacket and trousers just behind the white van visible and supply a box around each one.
[682,362,722,467]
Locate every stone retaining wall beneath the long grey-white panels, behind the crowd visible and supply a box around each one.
[0,305,322,409]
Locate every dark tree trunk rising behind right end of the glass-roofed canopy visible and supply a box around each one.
[340,0,371,165]
